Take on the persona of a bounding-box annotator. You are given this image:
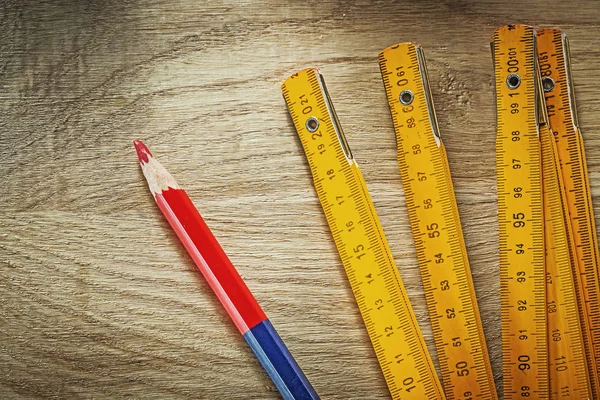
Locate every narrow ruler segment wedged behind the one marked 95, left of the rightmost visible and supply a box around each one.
[540,99,592,399]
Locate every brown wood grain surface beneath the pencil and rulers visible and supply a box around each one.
[0,0,600,399]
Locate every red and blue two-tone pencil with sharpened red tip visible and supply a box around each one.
[133,140,319,400]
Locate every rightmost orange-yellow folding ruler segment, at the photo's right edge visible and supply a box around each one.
[537,29,600,398]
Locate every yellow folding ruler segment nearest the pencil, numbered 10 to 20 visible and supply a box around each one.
[282,69,444,399]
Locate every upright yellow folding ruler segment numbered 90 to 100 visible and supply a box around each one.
[492,25,549,399]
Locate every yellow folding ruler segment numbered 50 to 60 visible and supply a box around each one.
[379,43,497,400]
